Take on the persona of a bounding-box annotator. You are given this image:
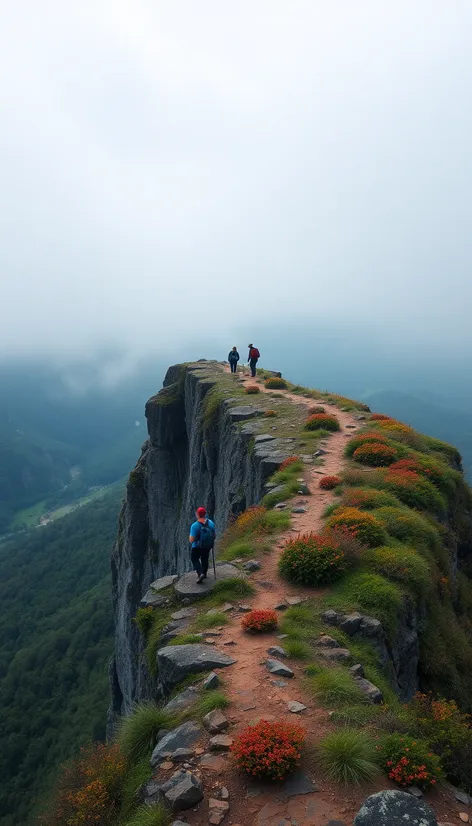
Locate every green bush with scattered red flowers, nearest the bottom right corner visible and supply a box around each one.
[379,733,441,788]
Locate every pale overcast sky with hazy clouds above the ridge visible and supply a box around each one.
[0,0,472,353]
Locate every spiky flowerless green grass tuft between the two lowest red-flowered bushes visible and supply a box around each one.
[317,728,379,786]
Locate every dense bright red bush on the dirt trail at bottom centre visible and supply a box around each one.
[232,720,305,780]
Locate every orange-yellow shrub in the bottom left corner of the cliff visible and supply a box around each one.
[41,743,126,826]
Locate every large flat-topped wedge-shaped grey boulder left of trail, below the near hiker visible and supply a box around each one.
[157,643,236,691]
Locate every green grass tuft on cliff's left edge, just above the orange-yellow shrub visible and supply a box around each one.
[117,702,172,762]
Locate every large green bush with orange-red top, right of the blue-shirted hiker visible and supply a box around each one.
[279,533,347,585]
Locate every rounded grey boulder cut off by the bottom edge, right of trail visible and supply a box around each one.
[354,789,437,826]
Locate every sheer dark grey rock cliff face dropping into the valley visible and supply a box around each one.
[110,362,289,715]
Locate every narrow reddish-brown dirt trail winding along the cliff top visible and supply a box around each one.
[186,374,382,826]
